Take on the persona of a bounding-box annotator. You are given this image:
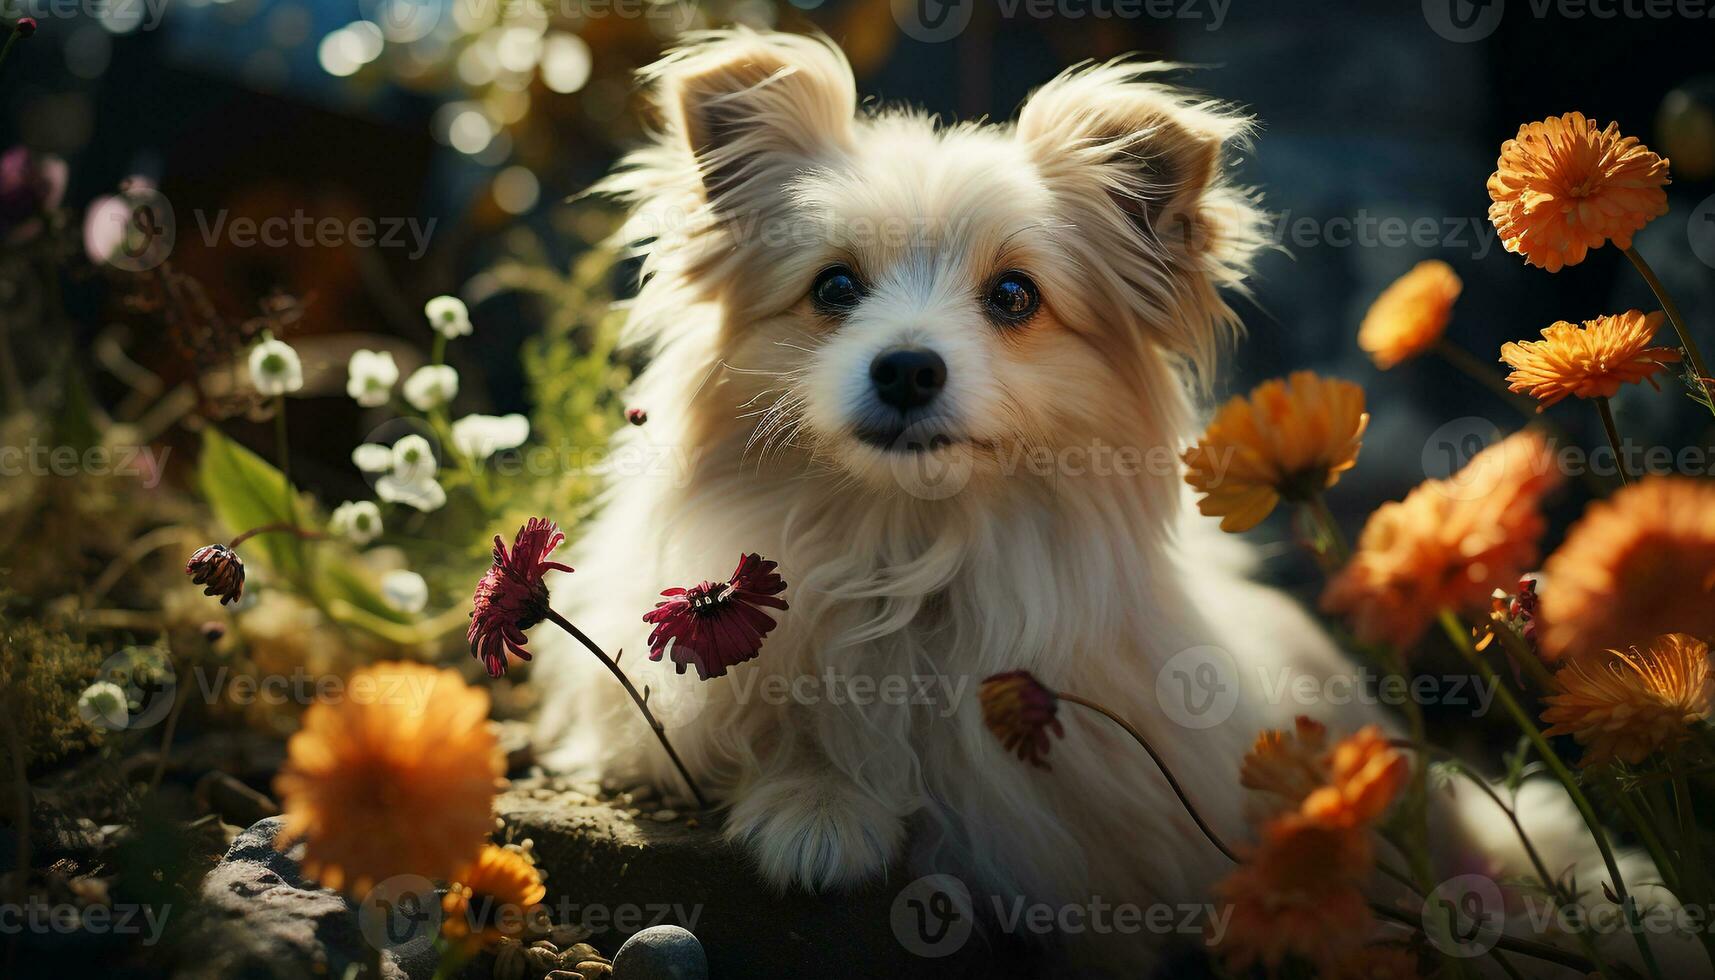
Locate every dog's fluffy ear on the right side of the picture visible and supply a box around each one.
[1017,62,1267,375]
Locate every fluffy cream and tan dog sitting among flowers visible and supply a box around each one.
[532,31,1701,977]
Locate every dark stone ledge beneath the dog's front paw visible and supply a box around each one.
[496,793,1029,980]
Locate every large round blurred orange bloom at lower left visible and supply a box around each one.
[274,662,506,896]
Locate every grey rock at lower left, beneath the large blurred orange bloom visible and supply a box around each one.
[189,817,439,980]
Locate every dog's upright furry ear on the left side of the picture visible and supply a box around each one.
[645,31,858,211]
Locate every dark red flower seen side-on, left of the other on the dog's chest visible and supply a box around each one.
[465,517,571,678]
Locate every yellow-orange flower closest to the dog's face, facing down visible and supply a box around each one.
[1183,371,1370,532]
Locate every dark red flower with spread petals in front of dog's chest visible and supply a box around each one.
[643,554,787,681]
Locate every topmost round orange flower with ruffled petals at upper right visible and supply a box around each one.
[1489,112,1667,273]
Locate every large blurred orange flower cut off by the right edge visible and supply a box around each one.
[1537,477,1715,662]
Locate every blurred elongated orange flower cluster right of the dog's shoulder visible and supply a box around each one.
[1322,431,1561,649]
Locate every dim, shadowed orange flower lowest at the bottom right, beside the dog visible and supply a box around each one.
[1211,814,1372,973]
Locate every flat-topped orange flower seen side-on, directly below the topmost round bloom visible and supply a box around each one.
[1501,309,1679,412]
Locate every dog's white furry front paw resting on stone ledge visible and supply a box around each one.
[725,777,906,892]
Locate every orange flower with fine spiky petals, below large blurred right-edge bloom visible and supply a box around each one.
[1542,633,1715,765]
